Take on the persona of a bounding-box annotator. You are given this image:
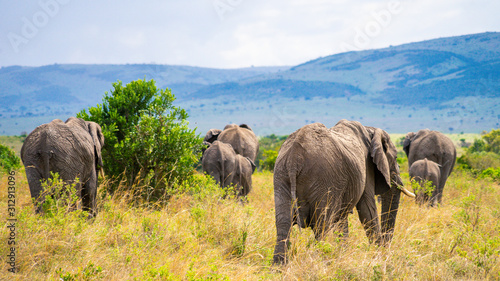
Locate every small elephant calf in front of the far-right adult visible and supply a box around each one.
[410,158,441,206]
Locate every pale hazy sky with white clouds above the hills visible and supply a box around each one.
[0,0,500,68]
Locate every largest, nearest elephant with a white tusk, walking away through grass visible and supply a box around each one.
[274,120,415,263]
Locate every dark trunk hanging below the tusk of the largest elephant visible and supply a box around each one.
[381,176,404,244]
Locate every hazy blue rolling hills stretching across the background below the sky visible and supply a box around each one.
[0,32,500,135]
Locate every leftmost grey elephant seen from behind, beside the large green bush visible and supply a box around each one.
[21,117,104,216]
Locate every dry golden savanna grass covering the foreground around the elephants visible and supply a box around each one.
[0,135,500,280]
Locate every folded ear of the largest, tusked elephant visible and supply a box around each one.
[370,128,396,188]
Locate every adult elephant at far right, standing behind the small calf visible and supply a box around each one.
[403,129,457,206]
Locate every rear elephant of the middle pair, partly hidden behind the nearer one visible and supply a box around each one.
[204,124,259,162]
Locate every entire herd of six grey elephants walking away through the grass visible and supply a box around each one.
[21,117,456,263]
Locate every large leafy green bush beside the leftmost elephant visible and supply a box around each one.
[77,77,201,198]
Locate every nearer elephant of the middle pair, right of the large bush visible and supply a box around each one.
[202,141,255,197]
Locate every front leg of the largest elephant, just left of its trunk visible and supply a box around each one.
[356,189,381,244]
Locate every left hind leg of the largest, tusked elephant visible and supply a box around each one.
[273,180,293,264]
